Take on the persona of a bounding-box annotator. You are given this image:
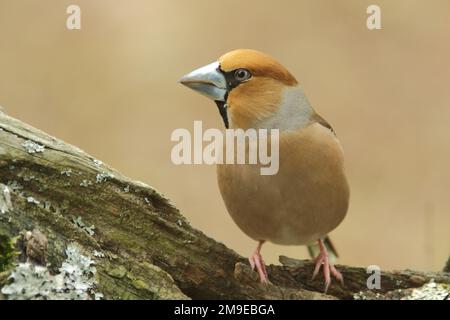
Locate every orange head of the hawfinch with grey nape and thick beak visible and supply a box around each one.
[180,49,310,129]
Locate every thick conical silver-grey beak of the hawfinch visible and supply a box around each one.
[180,62,227,101]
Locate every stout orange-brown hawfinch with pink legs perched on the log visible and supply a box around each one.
[179,49,350,292]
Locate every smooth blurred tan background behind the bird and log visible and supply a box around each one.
[0,0,450,270]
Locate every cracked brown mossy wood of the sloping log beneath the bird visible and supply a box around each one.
[0,112,450,299]
